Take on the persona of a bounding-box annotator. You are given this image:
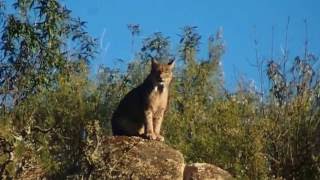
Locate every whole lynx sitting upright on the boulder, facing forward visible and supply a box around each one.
[111,60,174,141]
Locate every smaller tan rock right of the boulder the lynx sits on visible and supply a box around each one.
[183,163,233,180]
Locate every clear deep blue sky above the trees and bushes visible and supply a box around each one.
[63,0,320,89]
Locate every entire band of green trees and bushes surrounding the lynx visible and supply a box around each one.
[0,0,320,179]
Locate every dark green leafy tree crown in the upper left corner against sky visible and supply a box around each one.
[0,0,95,106]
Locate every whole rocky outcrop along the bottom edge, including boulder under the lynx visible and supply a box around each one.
[20,136,233,180]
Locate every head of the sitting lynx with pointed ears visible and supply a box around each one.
[150,59,174,86]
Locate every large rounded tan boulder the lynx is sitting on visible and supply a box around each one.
[91,136,185,179]
